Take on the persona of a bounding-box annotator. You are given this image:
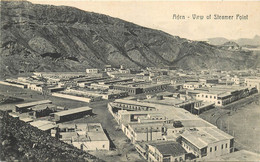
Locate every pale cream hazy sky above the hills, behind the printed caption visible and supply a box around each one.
[29,0,260,40]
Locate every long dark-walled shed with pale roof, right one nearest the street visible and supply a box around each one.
[51,106,92,122]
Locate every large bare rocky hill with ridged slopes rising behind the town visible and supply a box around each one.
[0,1,259,75]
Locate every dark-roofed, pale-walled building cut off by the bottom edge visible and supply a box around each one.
[147,141,187,162]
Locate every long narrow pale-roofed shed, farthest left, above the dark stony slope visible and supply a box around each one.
[15,100,52,113]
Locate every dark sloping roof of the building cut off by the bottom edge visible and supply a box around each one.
[148,141,187,157]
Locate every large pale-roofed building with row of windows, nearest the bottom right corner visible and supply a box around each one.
[180,127,234,159]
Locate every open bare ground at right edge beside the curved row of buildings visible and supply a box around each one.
[200,94,260,153]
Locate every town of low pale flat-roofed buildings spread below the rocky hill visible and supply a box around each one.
[0,65,260,162]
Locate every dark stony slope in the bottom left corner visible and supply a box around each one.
[0,111,101,162]
